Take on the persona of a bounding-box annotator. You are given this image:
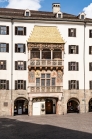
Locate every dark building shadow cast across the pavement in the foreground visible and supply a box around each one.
[0,118,92,139]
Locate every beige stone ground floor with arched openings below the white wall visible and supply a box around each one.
[0,90,92,116]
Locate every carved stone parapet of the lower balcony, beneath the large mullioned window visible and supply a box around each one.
[28,86,63,93]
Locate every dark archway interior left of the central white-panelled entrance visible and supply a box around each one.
[14,98,28,115]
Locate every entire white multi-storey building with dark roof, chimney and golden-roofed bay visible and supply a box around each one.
[0,3,92,116]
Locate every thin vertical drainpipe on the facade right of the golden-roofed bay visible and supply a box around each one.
[84,22,86,113]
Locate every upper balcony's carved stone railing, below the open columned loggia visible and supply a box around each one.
[28,59,63,67]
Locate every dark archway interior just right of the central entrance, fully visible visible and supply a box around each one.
[67,99,79,113]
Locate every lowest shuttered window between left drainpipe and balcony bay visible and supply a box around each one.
[15,80,26,90]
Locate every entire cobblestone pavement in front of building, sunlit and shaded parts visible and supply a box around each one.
[0,113,92,139]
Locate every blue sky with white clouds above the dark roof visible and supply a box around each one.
[0,0,92,18]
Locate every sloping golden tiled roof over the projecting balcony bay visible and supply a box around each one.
[27,26,65,43]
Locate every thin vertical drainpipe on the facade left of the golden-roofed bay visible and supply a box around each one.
[11,18,13,116]
